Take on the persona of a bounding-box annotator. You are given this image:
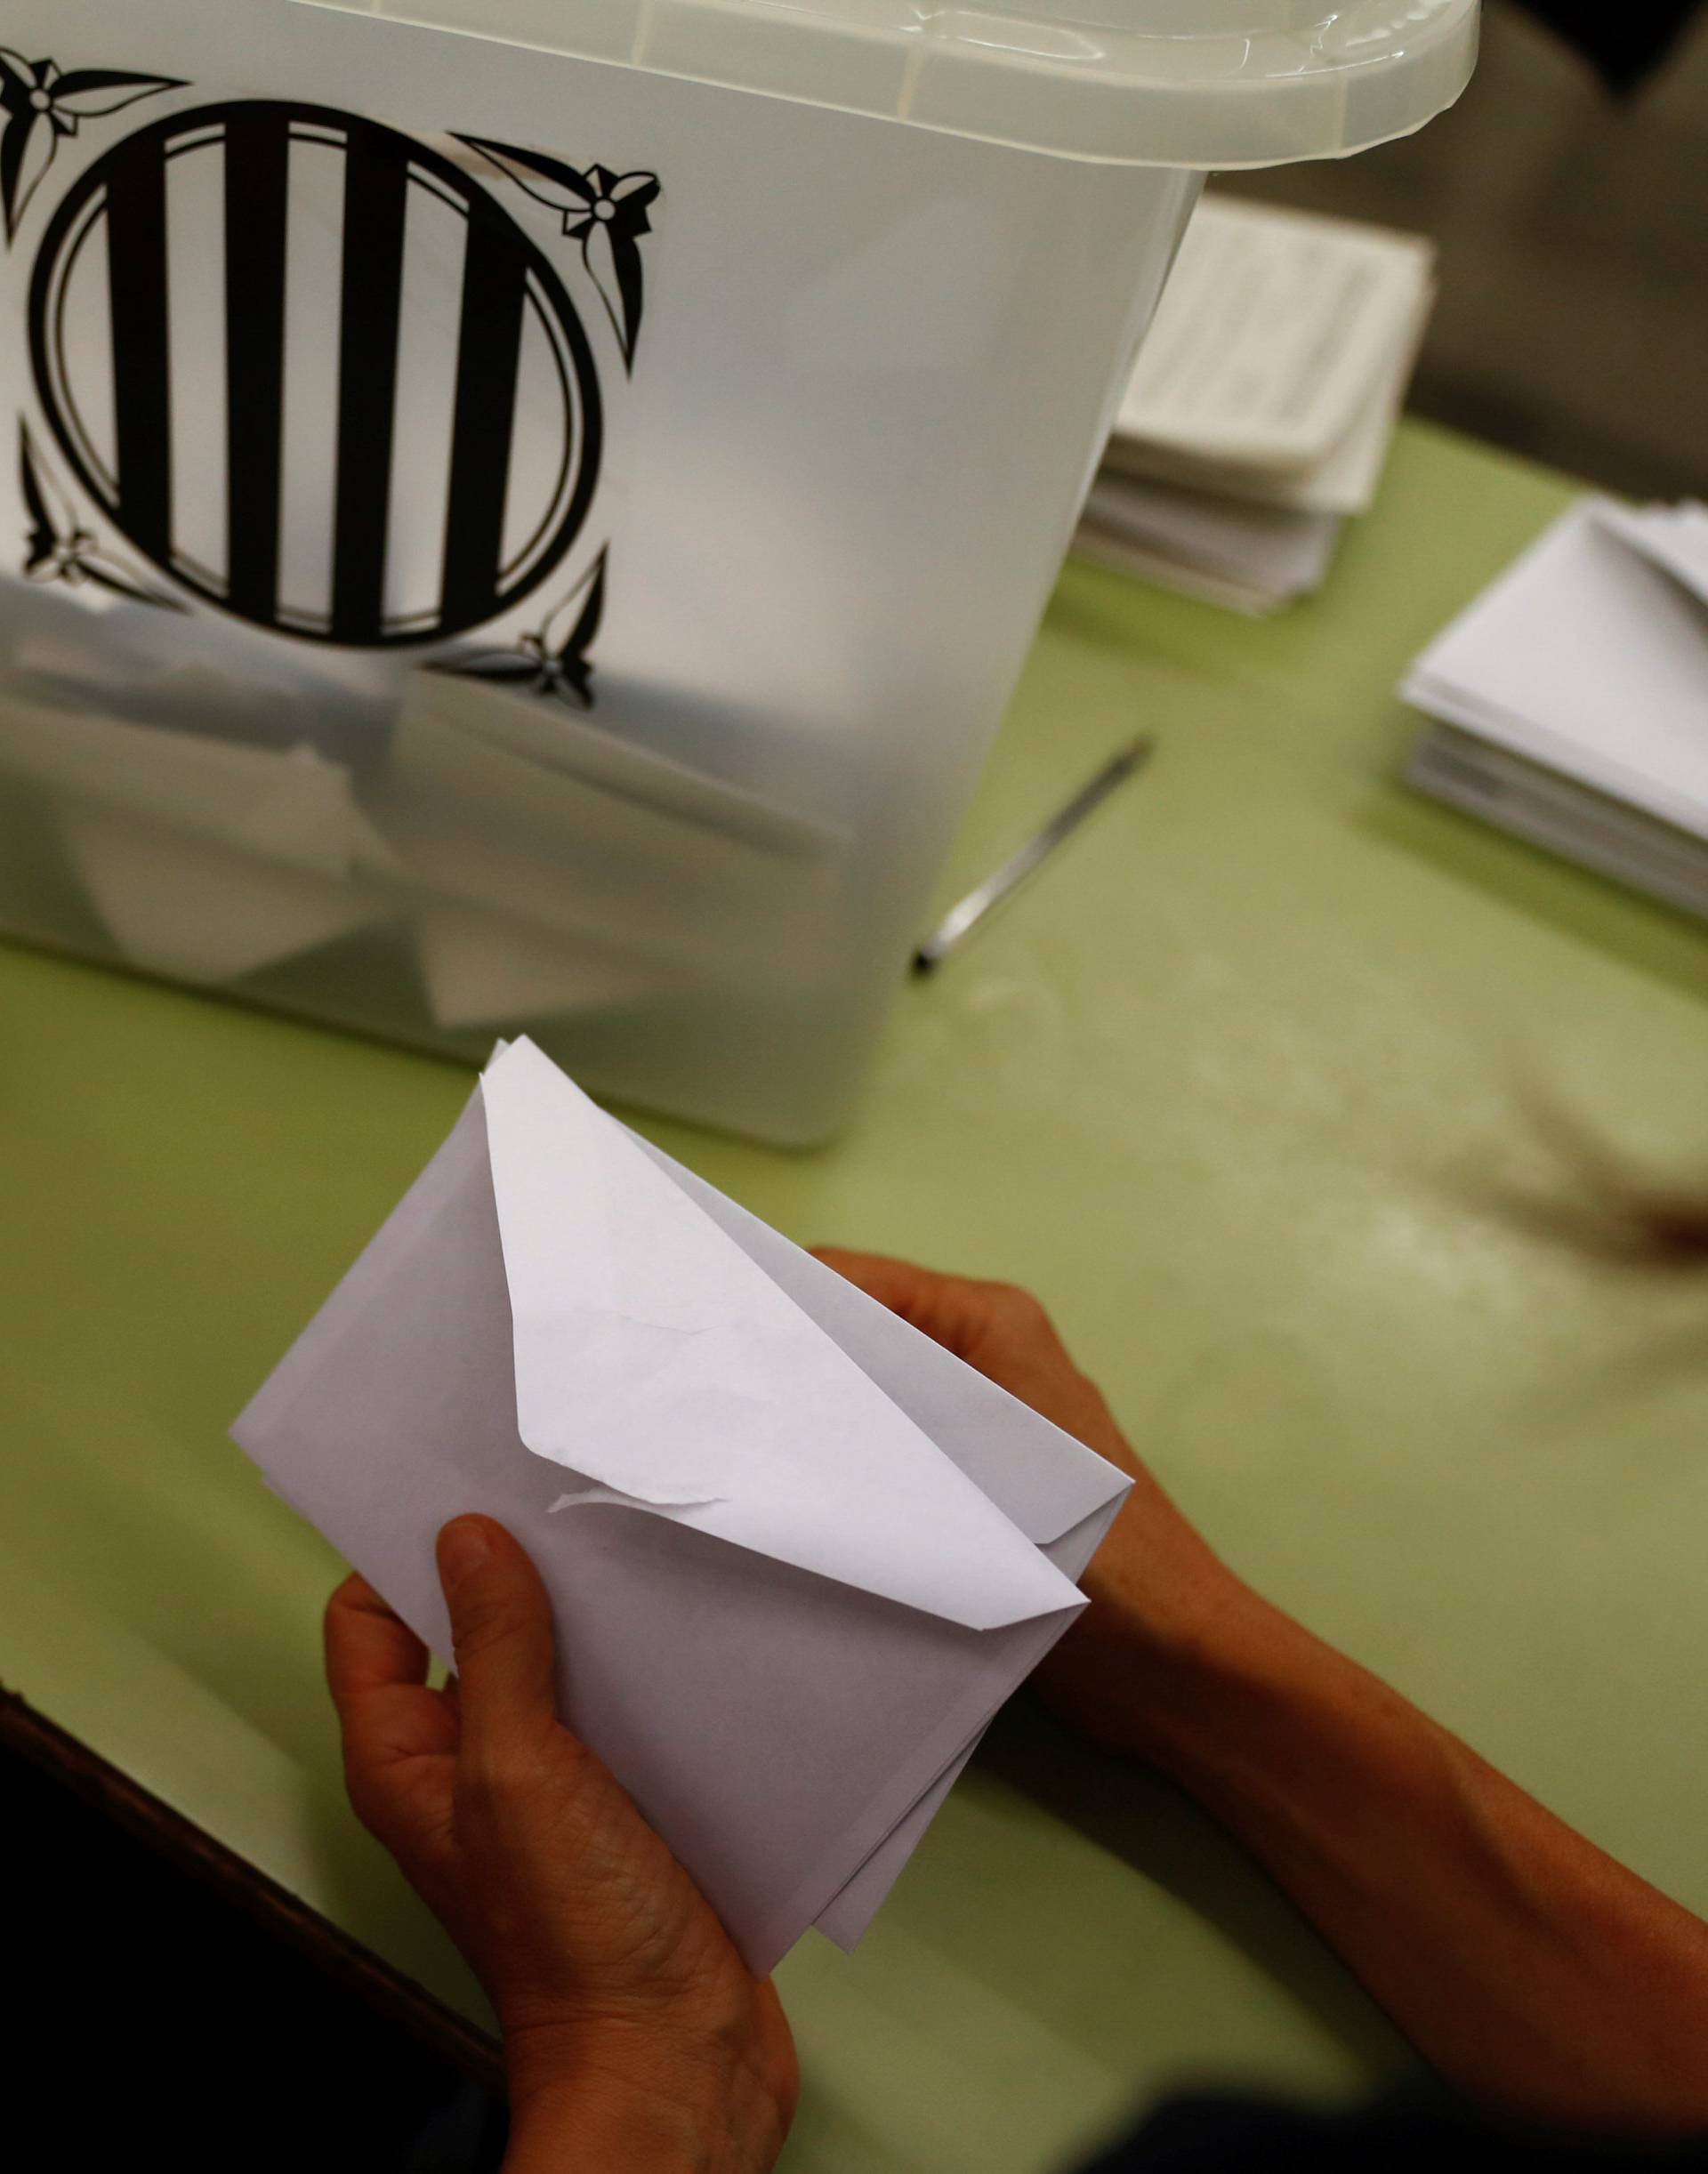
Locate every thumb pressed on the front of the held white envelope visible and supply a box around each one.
[439,1518,556,1739]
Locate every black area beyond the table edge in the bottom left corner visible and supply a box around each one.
[0,1746,502,2174]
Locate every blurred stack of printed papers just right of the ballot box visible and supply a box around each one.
[1074,196,1434,611]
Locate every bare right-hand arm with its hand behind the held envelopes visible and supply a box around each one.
[819,1252,1708,2135]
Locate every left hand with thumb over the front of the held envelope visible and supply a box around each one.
[326,1518,797,2174]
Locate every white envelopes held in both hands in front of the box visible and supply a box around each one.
[232,1042,1128,1969]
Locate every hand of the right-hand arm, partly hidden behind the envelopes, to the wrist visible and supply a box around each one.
[817,1245,1262,1757]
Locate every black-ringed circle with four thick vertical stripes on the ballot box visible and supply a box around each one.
[30,100,602,648]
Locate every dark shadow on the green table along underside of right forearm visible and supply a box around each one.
[978,1695,1414,2081]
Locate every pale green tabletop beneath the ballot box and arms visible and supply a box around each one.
[0,424,1708,2174]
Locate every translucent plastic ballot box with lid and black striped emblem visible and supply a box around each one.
[0,0,1478,1141]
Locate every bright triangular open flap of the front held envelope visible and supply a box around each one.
[469,1042,1080,1629]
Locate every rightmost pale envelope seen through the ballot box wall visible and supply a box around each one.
[374,672,848,1027]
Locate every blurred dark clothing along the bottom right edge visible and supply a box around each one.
[1086,2085,1708,2174]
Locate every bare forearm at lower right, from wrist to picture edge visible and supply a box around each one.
[1130,1581,1708,2133]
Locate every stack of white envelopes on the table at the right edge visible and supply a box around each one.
[1404,498,1708,915]
